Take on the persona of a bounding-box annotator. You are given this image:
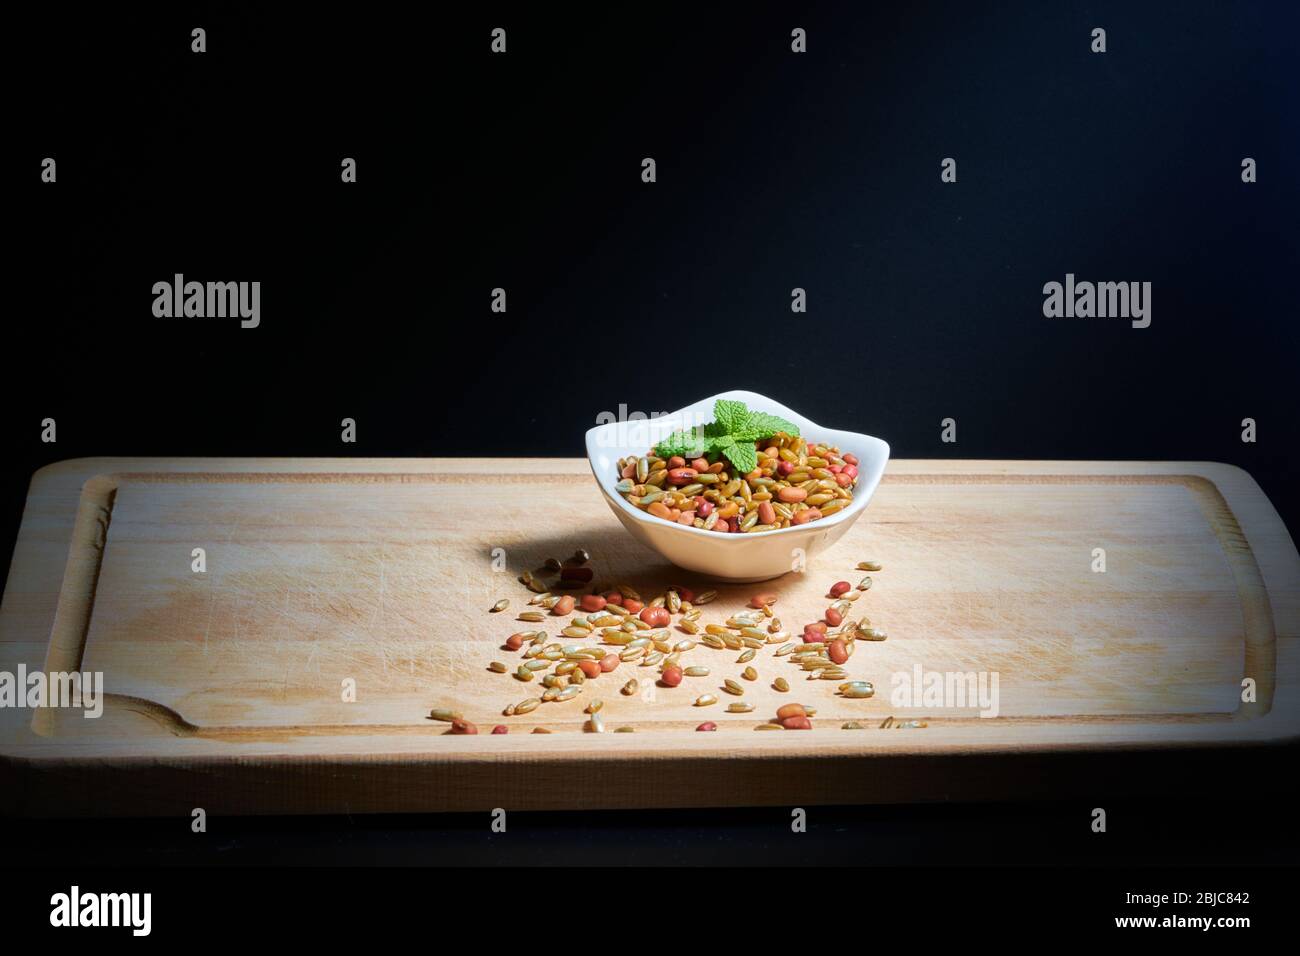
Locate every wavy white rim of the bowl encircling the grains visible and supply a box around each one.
[586,389,889,548]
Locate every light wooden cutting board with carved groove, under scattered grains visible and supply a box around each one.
[0,459,1300,814]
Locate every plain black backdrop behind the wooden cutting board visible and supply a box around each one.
[0,3,1300,862]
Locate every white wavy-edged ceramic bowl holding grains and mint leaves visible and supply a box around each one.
[586,392,889,581]
